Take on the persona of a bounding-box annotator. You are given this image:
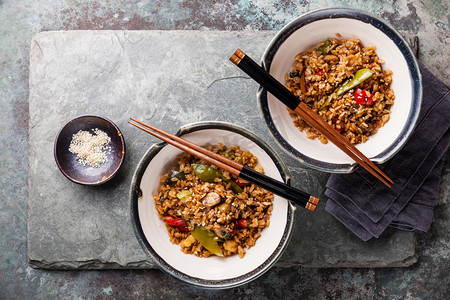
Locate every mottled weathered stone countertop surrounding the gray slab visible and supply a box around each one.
[0,0,450,299]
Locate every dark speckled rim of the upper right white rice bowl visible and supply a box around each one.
[257,8,422,173]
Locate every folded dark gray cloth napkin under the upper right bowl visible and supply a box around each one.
[325,65,450,241]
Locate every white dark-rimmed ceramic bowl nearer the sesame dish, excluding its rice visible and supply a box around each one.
[130,122,294,288]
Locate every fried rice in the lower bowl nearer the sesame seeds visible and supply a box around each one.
[153,144,273,258]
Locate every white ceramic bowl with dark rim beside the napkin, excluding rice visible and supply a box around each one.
[258,8,422,173]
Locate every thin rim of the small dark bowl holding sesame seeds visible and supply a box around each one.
[53,114,126,186]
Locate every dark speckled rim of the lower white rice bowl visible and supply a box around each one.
[129,121,296,289]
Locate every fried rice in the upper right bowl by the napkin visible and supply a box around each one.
[285,35,395,144]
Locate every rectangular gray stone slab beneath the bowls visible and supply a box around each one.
[28,31,417,269]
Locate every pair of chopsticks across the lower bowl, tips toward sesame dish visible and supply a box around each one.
[128,118,319,211]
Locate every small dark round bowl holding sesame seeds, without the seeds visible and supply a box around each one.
[54,115,125,185]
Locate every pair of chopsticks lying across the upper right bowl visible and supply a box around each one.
[230,49,394,187]
